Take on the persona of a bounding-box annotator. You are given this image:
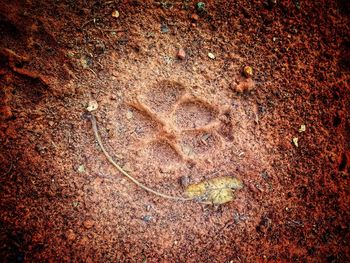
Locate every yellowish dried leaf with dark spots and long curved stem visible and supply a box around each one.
[185,176,243,205]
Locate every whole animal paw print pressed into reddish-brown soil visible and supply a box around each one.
[121,80,227,167]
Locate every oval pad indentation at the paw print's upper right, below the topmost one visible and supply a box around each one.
[174,100,216,129]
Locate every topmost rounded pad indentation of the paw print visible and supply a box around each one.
[141,80,185,114]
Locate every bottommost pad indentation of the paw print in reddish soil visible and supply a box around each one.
[146,140,182,166]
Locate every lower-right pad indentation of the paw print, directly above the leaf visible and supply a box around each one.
[180,131,220,157]
